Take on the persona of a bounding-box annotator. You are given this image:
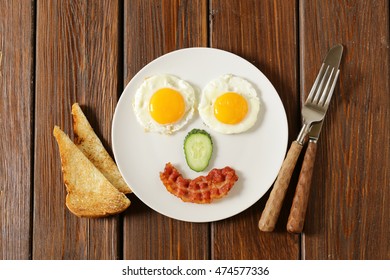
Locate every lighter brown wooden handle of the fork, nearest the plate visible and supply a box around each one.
[259,141,302,232]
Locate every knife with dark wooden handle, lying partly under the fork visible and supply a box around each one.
[287,48,343,233]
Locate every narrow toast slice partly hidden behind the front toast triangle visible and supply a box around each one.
[72,103,131,194]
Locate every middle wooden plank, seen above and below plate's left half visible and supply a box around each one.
[123,0,209,259]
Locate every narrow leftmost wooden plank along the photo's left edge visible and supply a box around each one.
[0,0,34,259]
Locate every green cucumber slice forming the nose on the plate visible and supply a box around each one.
[184,128,213,172]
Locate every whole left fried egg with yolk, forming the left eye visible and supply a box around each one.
[133,74,195,134]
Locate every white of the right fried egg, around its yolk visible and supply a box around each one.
[198,74,260,134]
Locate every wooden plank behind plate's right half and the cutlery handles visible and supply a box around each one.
[210,0,300,259]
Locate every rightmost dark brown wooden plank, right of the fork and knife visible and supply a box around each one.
[300,0,390,259]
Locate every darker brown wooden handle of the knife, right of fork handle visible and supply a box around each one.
[287,141,317,233]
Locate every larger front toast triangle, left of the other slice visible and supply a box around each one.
[53,126,130,218]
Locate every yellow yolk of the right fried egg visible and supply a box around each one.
[214,92,248,124]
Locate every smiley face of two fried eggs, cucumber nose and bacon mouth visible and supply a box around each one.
[133,75,260,204]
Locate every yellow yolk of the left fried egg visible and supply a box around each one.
[149,88,185,124]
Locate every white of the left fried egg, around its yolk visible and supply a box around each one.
[133,74,196,134]
